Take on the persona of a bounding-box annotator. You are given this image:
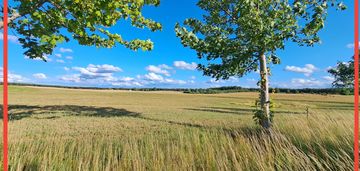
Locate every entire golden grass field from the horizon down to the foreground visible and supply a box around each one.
[1,86,353,171]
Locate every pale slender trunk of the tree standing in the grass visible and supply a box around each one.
[260,53,271,129]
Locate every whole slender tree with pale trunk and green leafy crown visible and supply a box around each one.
[175,0,345,129]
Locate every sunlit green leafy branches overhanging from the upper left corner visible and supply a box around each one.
[2,0,162,60]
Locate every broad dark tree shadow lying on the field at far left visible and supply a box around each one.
[0,105,140,121]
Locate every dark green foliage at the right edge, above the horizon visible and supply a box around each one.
[328,54,355,89]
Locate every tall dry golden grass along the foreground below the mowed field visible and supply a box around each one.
[0,111,353,171]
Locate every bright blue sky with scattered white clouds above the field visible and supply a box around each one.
[0,0,354,88]
